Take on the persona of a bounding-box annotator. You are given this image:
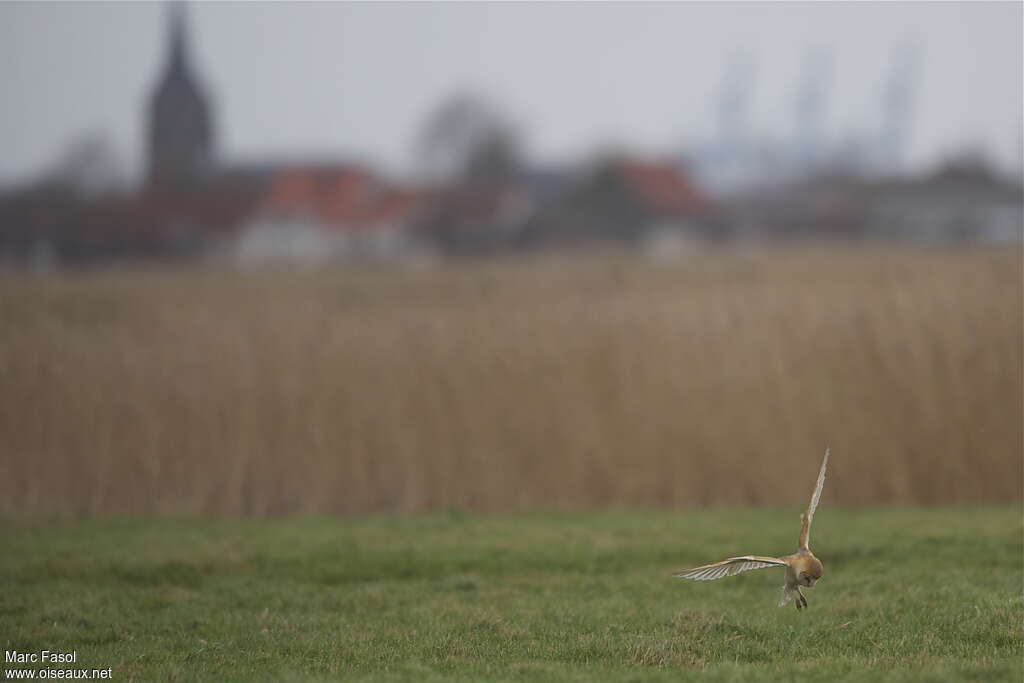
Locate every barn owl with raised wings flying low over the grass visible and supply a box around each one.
[673,449,828,609]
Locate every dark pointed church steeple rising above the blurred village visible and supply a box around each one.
[146,2,213,189]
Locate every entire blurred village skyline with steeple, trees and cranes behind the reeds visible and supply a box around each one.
[0,9,1024,267]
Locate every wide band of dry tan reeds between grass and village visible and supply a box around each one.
[0,250,1022,515]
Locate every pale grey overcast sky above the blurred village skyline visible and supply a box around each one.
[0,2,1024,184]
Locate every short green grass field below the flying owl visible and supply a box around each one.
[0,504,1024,681]
